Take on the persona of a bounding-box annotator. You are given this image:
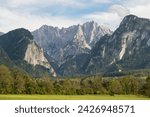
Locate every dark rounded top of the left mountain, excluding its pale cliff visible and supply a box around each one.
[0,28,33,60]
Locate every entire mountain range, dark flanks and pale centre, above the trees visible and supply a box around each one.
[0,15,150,76]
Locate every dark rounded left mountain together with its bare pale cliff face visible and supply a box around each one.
[0,29,56,76]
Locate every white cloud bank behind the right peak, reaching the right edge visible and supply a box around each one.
[84,0,150,30]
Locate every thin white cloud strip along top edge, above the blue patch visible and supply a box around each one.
[3,0,112,9]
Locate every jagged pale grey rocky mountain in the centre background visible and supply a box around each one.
[32,21,111,64]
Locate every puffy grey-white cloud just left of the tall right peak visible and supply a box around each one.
[83,5,130,30]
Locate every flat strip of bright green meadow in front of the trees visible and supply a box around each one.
[0,95,150,100]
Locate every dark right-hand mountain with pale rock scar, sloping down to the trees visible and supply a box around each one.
[59,15,150,75]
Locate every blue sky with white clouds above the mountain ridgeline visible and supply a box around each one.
[0,0,150,32]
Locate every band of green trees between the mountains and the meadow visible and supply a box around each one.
[0,65,150,97]
